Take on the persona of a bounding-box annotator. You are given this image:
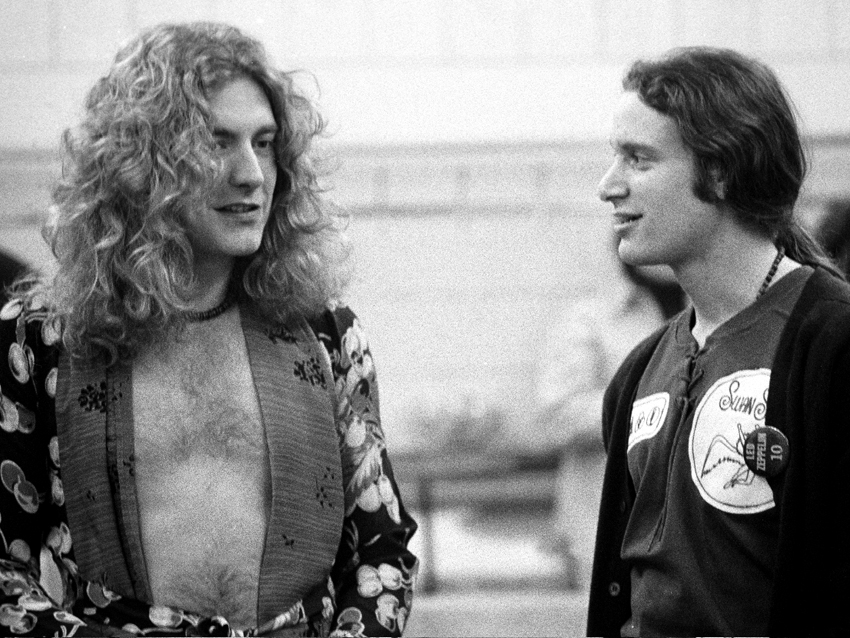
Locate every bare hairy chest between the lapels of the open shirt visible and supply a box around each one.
[133,312,271,626]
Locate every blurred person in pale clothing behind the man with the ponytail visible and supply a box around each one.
[535,258,686,588]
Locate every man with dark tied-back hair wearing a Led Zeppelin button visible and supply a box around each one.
[588,47,850,636]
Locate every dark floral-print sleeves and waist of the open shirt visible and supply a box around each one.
[0,300,417,636]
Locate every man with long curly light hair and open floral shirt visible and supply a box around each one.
[0,23,416,635]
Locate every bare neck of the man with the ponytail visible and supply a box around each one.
[674,233,799,347]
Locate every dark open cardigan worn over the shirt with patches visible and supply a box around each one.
[587,269,850,636]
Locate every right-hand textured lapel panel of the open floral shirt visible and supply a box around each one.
[242,311,344,624]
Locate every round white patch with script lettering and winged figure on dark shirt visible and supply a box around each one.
[688,368,774,514]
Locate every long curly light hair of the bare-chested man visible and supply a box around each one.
[27,22,349,362]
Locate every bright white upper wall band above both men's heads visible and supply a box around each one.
[0,0,850,149]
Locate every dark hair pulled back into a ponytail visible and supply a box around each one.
[623,47,839,274]
